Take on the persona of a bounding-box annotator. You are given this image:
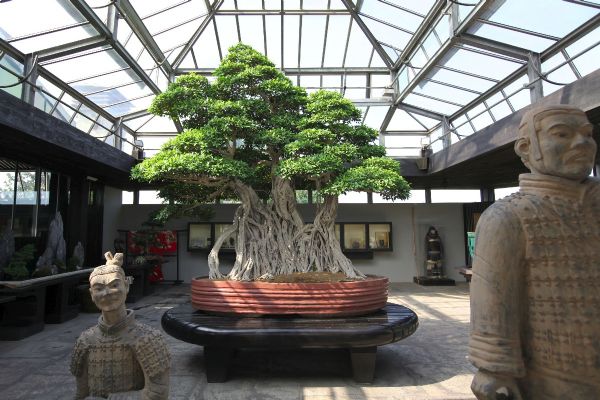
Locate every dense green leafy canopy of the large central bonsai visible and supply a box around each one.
[132,44,409,216]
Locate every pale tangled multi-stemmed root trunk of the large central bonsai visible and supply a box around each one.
[208,177,364,280]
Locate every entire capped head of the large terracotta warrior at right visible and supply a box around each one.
[515,104,596,182]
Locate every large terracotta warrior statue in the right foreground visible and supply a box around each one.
[469,105,600,400]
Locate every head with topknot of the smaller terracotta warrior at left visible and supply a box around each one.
[90,253,129,312]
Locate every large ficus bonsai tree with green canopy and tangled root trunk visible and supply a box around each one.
[132,44,410,280]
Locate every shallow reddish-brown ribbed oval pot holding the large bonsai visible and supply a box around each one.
[192,275,388,317]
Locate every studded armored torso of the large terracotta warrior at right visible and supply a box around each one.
[518,195,600,379]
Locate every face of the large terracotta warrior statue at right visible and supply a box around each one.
[529,113,596,181]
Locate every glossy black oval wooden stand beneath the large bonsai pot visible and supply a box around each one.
[161,303,419,383]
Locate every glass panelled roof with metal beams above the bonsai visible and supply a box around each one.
[0,0,600,157]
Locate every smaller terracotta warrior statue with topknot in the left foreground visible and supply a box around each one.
[71,252,170,400]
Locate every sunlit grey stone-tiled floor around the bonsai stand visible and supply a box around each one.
[0,283,474,400]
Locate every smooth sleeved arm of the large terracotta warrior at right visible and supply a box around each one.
[469,203,526,399]
